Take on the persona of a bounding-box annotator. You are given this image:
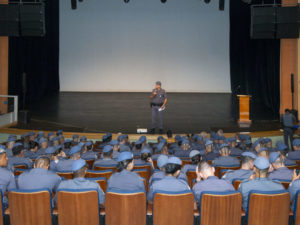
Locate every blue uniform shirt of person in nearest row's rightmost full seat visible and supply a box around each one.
[238,178,285,211]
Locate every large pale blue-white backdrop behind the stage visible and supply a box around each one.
[60,0,230,92]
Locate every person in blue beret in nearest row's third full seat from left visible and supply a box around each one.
[107,152,145,191]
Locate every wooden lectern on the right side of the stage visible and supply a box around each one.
[237,95,251,127]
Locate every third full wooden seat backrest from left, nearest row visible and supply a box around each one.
[105,192,146,225]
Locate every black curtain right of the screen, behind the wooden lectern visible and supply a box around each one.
[230,0,280,120]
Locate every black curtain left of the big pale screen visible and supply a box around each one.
[8,0,59,107]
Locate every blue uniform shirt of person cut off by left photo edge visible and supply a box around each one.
[0,167,17,207]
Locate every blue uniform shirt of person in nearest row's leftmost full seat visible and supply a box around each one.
[18,168,61,191]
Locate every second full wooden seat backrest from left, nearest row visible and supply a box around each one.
[57,189,99,225]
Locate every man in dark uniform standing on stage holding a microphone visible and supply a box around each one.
[150,81,168,134]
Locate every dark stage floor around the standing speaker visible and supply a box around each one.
[10,92,280,133]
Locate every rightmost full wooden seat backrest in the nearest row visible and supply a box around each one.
[247,191,290,225]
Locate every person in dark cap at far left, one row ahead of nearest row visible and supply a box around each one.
[8,143,33,170]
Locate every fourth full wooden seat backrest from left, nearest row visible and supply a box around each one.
[153,191,194,225]
